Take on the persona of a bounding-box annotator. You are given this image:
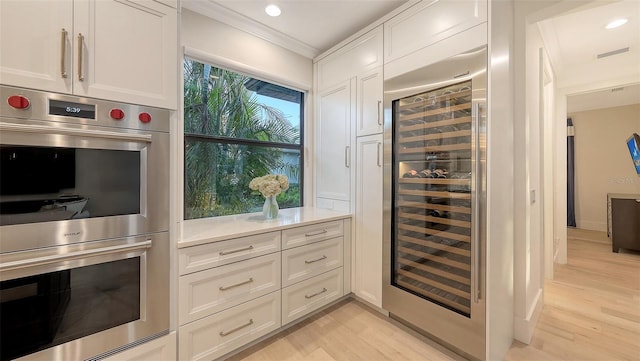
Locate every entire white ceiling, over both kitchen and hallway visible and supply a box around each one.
[182,0,640,111]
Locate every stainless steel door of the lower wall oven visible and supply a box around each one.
[0,232,169,360]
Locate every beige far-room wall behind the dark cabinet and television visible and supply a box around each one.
[569,104,640,232]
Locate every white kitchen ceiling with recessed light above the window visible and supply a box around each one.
[182,0,408,58]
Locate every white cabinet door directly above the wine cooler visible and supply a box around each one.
[384,0,487,63]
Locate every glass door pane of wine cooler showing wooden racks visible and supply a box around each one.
[391,80,473,317]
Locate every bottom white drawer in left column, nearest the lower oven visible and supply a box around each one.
[178,292,280,361]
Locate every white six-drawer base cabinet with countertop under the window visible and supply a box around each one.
[177,211,351,360]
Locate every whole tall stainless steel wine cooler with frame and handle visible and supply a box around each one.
[383,47,487,359]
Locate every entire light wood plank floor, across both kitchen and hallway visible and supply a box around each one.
[230,230,640,361]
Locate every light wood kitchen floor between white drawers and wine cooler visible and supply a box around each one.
[228,299,463,361]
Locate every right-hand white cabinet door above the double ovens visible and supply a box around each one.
[73,0,178,109]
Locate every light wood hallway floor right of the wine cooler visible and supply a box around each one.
[506,229,640,361]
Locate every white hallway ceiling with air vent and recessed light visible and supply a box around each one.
[538,0,640,111]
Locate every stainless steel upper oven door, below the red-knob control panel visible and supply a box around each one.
[0,117,169,253]
